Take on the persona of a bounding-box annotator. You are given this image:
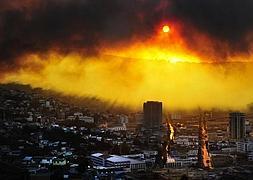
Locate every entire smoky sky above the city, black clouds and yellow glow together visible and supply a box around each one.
[0,0,253,110]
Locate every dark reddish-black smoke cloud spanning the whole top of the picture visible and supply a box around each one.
[0,0,253,64]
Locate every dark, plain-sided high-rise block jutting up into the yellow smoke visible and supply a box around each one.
[143,101,162,129]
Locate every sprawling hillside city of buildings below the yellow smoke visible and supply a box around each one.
[0,84,253,179]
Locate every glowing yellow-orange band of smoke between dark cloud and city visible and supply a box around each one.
[3,25,253,109]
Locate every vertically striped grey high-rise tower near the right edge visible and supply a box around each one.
[229,112,245,140]
